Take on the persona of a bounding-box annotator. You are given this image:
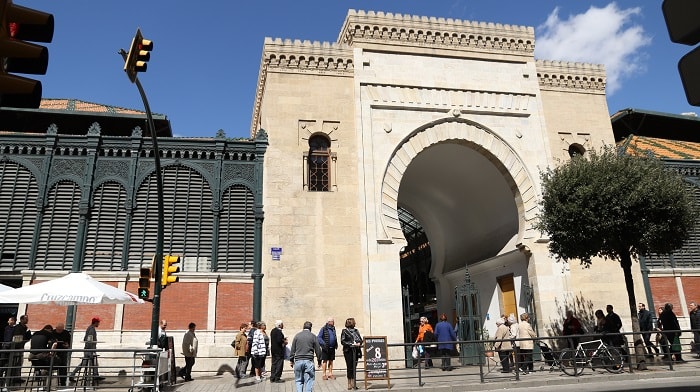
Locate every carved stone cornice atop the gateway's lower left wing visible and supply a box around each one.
[250,38,354,138]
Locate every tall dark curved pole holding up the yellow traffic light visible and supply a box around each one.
[119,49,165,348]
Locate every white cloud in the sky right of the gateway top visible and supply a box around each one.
[535,2,651,95]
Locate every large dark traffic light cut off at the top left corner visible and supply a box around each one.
[0,0,53,108]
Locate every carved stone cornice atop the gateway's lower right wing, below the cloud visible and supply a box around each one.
[536,60,606,94]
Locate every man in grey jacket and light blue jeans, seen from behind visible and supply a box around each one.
[290,321,321,392]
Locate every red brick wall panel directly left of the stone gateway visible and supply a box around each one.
[216,283,253,331]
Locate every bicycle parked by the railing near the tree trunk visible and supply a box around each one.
[559,339,624,376]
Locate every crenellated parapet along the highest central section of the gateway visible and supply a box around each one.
[338,10,535,56]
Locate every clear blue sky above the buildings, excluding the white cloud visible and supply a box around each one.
[19,0,696,137]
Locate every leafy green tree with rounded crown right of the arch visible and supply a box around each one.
[535,147,697,368]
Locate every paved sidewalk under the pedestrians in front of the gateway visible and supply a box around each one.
[170,355,700,392]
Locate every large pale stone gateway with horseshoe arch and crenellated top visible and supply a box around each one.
[251,11,644,358]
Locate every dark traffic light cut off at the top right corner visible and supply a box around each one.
[661,0,700,106]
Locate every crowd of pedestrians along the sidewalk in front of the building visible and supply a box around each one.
[0,302,700,392]
